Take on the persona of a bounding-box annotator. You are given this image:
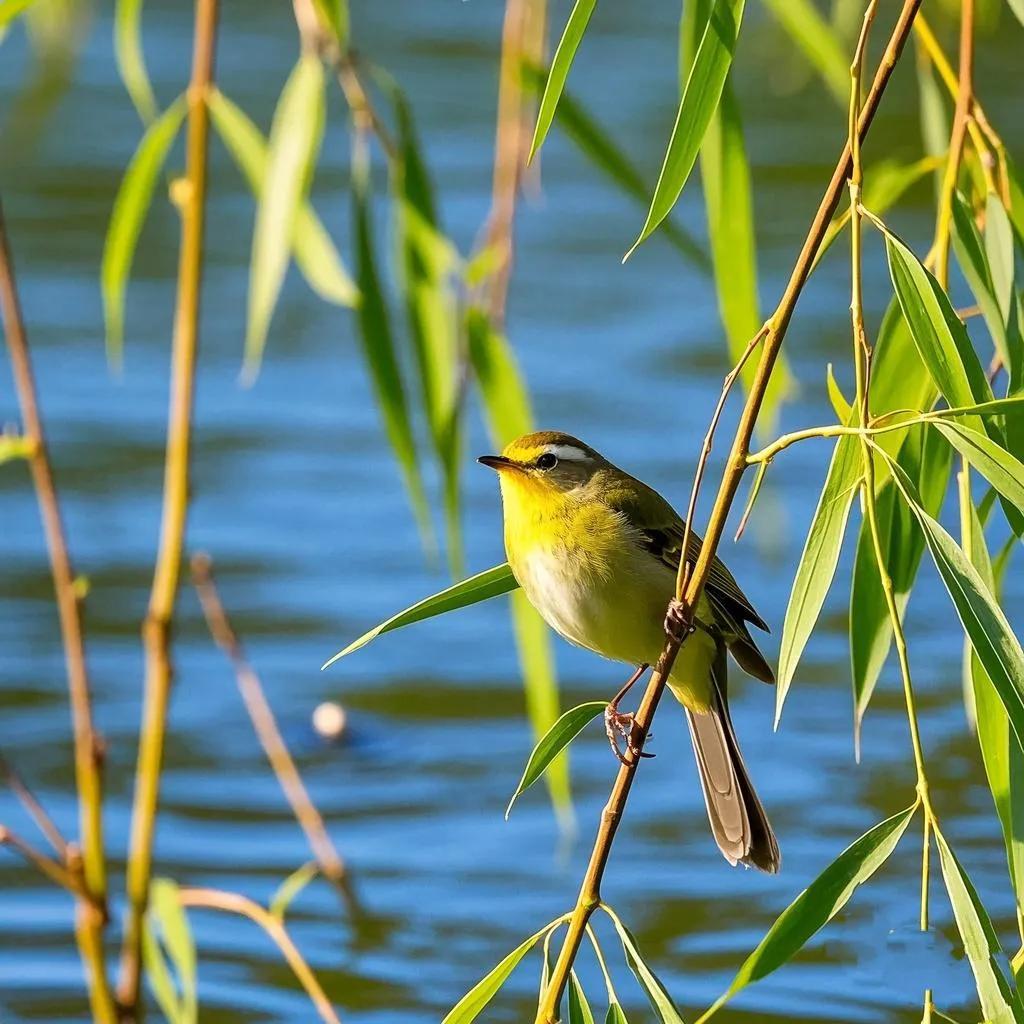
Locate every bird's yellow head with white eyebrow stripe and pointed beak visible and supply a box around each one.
[477,430,611,502]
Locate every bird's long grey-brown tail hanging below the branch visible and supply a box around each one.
[686,643,781,874]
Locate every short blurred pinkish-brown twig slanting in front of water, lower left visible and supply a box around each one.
[191,554,353,906]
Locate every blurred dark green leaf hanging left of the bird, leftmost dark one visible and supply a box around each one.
[354,145,436,554]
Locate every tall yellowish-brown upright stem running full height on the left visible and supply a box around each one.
[119,0,218,1011]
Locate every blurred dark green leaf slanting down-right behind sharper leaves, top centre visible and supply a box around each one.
[523,65,711,273]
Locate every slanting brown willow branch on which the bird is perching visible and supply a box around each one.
[537,0,921,1024]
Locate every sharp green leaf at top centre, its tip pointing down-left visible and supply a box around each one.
[624,0,743,259]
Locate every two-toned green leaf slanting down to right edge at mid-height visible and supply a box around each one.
[889,452,1024,742]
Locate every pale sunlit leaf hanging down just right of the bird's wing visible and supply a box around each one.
[775,435,860,728]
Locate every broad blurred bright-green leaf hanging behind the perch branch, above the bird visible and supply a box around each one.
[680,0,792,432]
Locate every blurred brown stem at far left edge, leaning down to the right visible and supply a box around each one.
[0,204,116,1021]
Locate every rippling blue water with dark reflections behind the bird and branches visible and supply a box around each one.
[0,0,1022,1024]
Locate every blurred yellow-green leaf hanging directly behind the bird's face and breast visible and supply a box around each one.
[466,308,571,826]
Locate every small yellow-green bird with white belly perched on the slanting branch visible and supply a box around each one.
[478,431,780,873]
